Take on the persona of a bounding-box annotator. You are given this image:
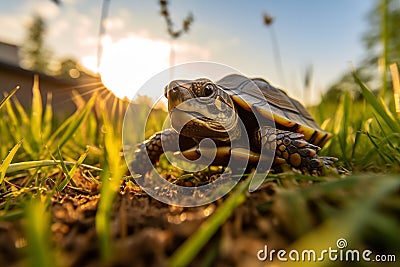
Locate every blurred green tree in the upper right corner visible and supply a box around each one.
[325,0,400,104]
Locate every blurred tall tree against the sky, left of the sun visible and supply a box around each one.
[21,14,51,72]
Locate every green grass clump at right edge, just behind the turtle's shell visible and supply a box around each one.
[312,70,400,172]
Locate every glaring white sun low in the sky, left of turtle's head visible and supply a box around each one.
[99,35,170,99]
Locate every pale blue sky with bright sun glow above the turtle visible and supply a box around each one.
[0,0,375,103]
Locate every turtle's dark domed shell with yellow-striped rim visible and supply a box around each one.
[217,74,331,147]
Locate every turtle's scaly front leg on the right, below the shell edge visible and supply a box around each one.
[260,127,337,175]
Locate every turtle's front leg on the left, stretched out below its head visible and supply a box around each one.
[131,129,195,174]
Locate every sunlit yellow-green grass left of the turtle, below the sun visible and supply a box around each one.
[0,77,126,266]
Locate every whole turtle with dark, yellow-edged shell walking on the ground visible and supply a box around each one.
[131,74,337,175]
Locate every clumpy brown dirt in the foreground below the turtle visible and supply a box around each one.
[0,169,290,266]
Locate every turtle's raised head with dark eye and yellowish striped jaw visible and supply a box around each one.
[165,79,240,140]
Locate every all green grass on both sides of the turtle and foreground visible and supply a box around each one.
[0,59,400,266]
